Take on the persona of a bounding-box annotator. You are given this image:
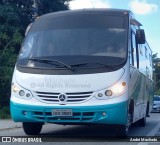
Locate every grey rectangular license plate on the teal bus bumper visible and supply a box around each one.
[52,109,73,116]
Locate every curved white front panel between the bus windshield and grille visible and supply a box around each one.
[14,68,125,93]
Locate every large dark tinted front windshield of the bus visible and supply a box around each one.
[18,14,128,67]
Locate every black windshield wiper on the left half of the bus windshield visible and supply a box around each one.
[29,58,74,71]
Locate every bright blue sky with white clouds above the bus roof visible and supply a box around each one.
[69,0,160,57]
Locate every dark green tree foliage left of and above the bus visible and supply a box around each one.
[0,0,70,108]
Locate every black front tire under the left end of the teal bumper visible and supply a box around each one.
[22,122,43,135]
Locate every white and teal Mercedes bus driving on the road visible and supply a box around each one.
[10,9,153,136]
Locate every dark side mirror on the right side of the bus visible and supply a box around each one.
[136,29,146,44]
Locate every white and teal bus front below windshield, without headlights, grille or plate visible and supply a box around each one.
[10,63,129,124]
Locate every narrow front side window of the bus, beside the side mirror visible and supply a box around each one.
[131,32,139,68]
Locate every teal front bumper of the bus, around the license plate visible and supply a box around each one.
[10,101,128,124]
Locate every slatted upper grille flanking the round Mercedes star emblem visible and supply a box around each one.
[35,92,93,103]
